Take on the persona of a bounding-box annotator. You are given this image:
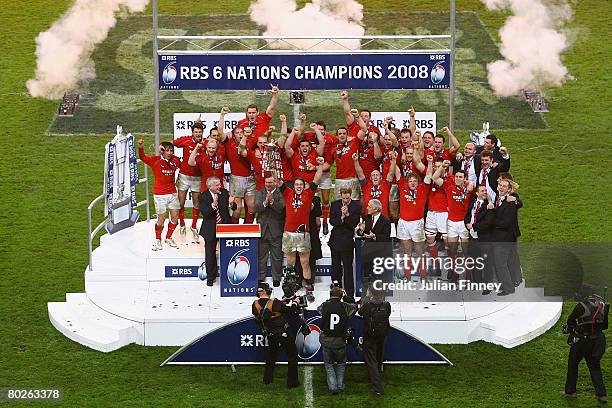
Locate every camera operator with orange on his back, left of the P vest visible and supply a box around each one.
[251,282,299,388]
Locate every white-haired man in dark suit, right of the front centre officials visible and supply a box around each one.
[357,199,392,284]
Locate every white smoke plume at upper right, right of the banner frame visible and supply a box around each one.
[482,0,572,96]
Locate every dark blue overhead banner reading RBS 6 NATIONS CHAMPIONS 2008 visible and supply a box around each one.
[158,52,450,91]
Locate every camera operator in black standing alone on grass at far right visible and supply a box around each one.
[561,285,610,403]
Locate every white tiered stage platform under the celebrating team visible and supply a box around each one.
[48,220,562,352]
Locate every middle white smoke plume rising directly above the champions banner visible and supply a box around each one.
[249,0,365,50]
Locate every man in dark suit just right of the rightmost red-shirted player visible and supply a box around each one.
[464,185,495,295]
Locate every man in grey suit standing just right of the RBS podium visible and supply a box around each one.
[255,175,285,287]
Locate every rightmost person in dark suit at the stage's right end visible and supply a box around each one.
[493,178,523,296]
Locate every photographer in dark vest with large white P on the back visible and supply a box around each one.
[317,282,357,394]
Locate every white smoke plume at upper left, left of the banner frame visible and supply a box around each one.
[26,0,149,99]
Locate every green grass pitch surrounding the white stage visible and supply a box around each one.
[0,0,612,407]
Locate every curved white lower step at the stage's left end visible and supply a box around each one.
[47,293,144,352]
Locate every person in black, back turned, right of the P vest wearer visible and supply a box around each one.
[359,285,391,395]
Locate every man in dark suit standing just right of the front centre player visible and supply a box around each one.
[328,187,361,298]
